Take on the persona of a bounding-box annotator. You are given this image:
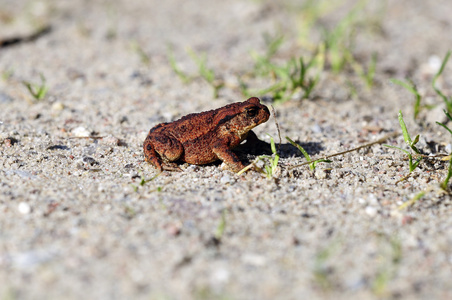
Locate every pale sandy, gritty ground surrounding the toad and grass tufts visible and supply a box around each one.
[0,0,452,299]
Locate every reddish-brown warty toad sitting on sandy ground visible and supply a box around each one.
[143,97,270,172]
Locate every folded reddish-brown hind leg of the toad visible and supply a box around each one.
[143,134,184,171]
